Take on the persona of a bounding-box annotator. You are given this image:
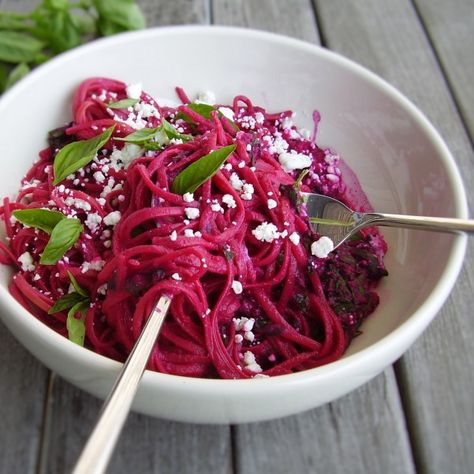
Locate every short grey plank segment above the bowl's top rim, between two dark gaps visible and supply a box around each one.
[211,0,318,42]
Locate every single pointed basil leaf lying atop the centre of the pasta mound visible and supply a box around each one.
[171,145,236,195]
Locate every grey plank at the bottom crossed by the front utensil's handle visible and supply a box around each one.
[40,377,231,474]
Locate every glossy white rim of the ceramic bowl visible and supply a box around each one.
[0,25,468,395]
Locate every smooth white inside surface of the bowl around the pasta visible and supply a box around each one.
[0,27,466,421]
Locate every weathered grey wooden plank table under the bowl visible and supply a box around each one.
[0,0,474,474]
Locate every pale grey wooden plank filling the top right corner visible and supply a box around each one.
[415,0,474,140]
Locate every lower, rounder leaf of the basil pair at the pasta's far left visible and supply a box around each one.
[40,217,84,265]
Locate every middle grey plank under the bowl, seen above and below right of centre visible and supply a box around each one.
[212,0,414,474]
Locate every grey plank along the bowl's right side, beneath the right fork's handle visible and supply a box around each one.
[316,0,474,473]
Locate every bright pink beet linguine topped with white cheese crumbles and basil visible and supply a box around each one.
[0,78,387,379]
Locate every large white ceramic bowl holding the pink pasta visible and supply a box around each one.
[0,26,467,423]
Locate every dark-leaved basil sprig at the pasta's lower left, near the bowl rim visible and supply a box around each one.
[48,272,90,346]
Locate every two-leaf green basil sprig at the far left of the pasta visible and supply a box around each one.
[13,209,84,265]
